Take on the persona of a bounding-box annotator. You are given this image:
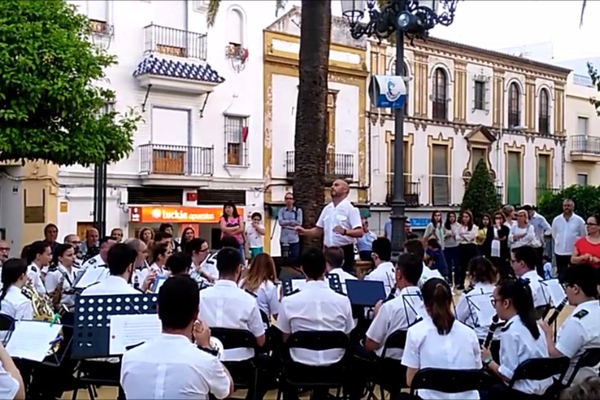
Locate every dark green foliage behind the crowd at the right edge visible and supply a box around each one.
[538,185,600,222]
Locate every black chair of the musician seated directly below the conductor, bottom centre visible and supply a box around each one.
[277,331,350,400]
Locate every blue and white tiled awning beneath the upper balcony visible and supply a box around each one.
[133,54,225,84]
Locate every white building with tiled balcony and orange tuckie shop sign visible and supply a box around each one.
[58,0,275,242]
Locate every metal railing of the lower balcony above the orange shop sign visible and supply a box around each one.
[139,143,214,176]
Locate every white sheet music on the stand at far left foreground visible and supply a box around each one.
[6,321,62,362]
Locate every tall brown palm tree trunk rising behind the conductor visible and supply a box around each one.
[294,0,331,250]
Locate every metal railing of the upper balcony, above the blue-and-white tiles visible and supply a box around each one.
[144,24,206,60]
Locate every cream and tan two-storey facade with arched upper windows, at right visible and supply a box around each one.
[367,38,569,232]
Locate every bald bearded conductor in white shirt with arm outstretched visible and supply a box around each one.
[296,179,364,273]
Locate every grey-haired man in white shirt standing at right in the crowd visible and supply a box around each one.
[552,199,587,277]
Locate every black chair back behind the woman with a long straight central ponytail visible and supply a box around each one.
[410,368,496,396]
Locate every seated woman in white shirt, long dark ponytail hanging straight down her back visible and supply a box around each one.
[402,278,481,400]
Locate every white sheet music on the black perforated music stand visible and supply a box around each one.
[108,314,162,356]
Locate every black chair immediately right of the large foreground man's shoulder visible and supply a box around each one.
[210,328,258,390]
